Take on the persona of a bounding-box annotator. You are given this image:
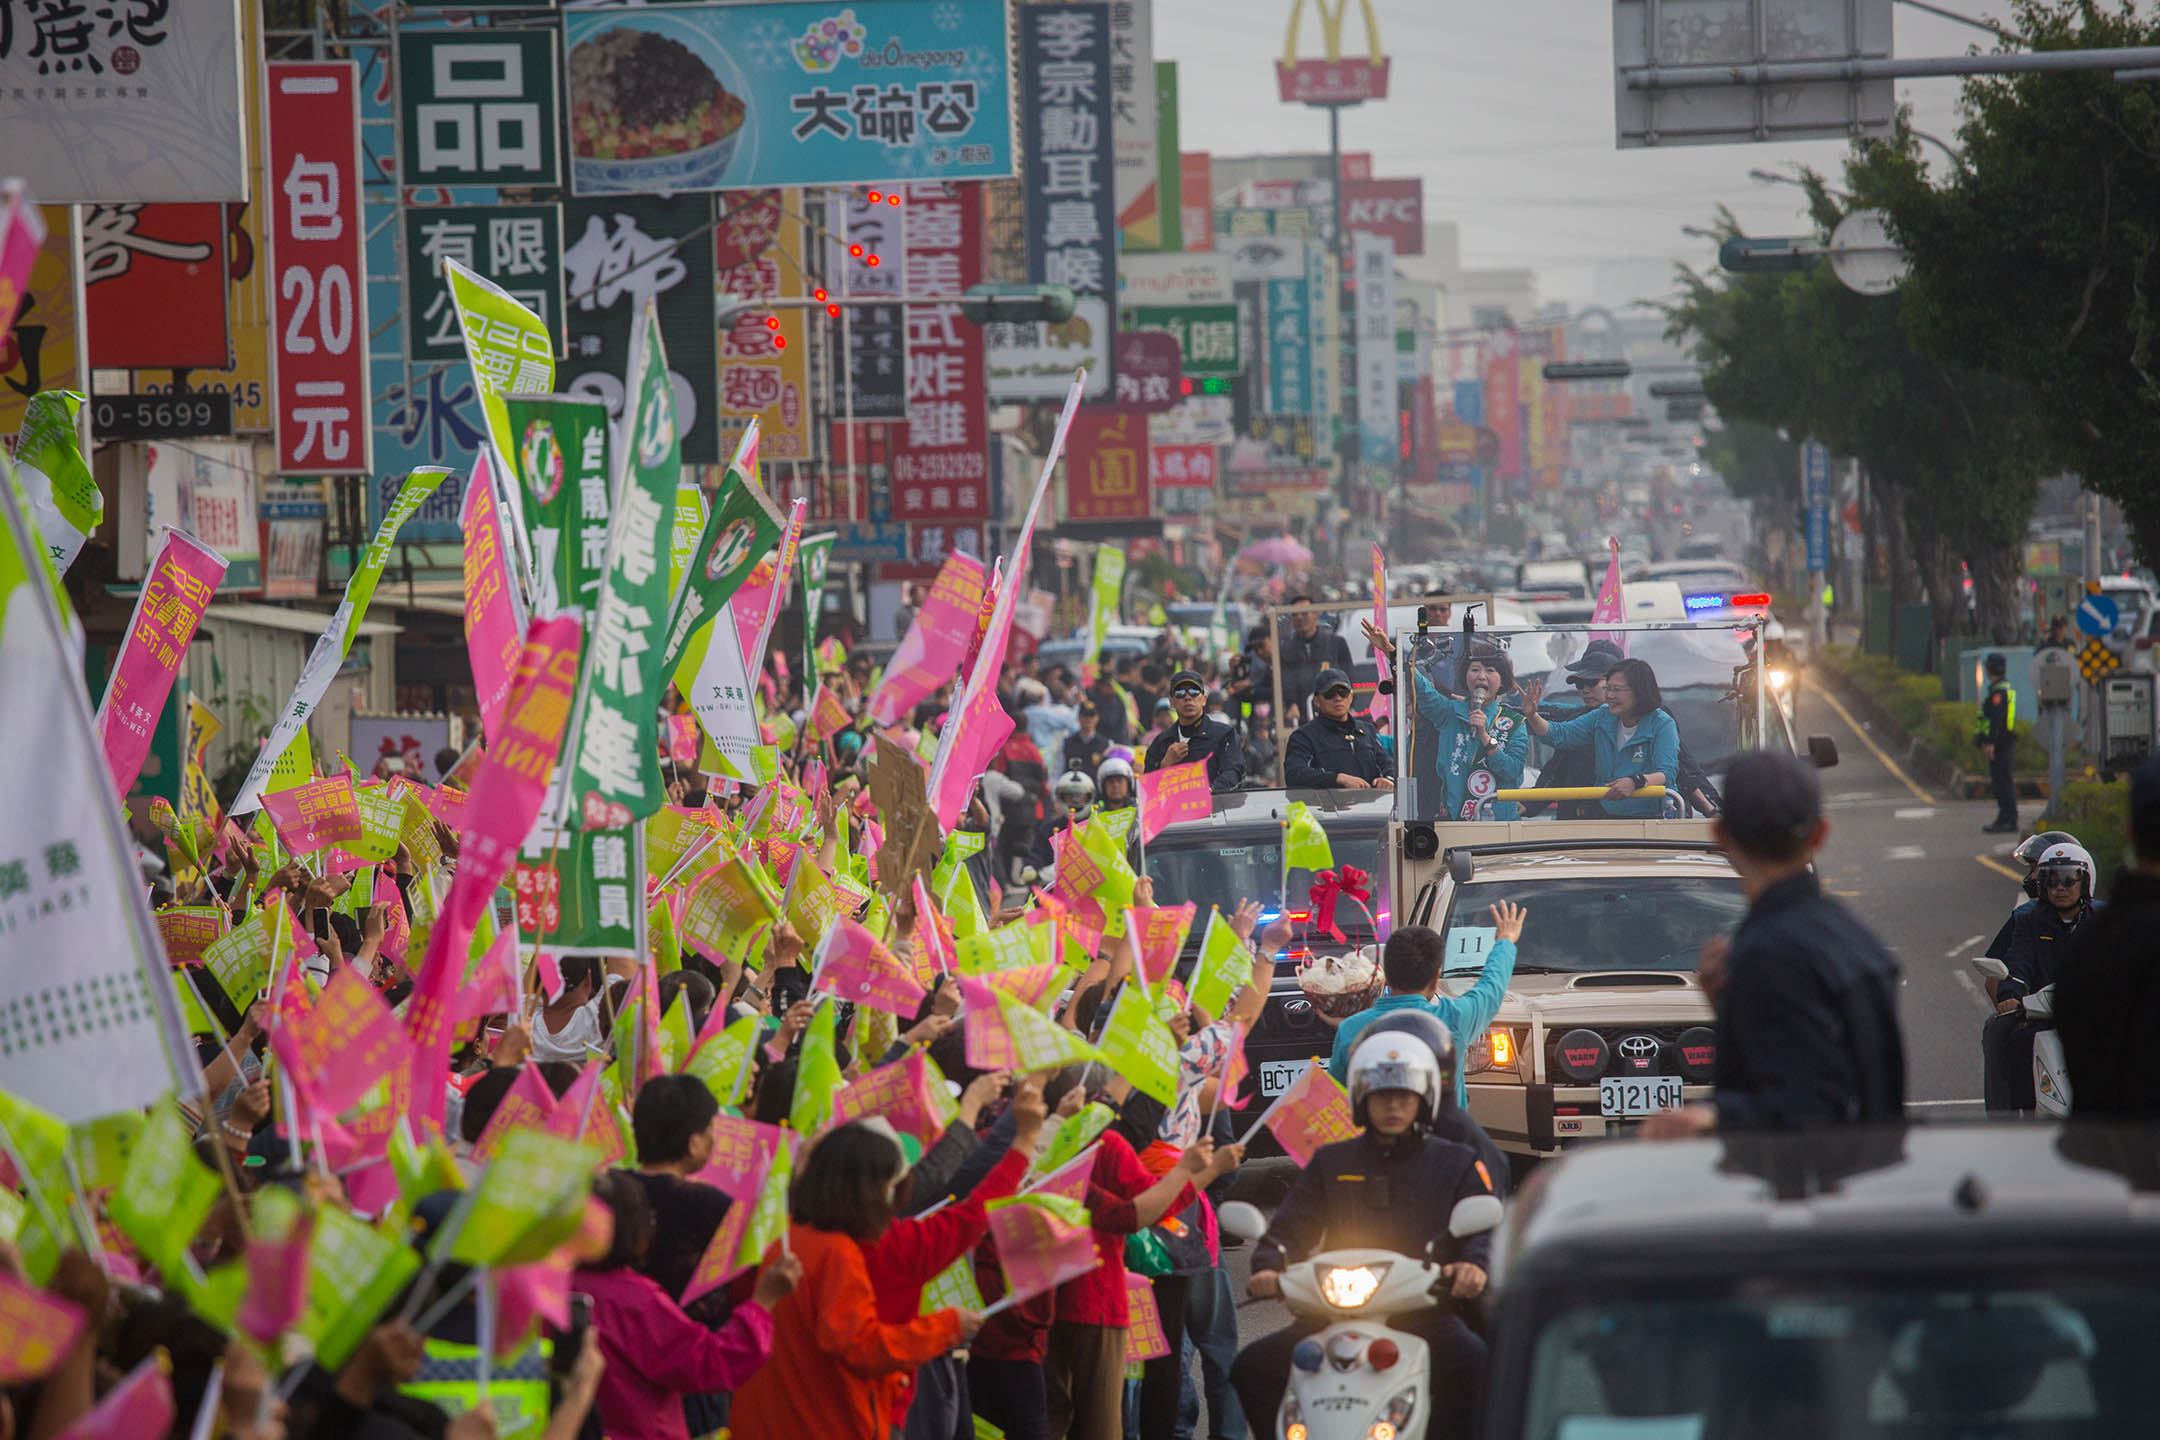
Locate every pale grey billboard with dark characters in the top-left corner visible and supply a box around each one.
[0,0,257,205]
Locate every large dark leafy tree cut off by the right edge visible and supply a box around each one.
[1871,0,2160,563]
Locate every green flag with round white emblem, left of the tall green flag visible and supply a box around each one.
[501,395,613,628]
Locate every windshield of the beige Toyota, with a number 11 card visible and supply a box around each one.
[1443,874,1747,976]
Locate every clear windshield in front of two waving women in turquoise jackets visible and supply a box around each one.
[1395,622,1760,820]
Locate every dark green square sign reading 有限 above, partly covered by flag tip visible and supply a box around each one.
[404,205,564,361]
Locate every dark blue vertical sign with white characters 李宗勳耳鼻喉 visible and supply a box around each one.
[985,4,1117,399]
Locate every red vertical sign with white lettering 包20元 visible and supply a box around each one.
[266,60,374,475]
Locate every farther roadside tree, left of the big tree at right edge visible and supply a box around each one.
[1668,142,2048,641]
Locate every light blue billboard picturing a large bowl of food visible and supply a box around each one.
[564,0,1019,194]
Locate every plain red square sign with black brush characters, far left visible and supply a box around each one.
[82,205,233,371]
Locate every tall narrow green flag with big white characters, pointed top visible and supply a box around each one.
[562,300,683,829]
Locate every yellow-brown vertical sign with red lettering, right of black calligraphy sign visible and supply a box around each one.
[713,190,810,460]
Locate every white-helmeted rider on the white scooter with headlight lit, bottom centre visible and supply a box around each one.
[1231,1021,1493,1440]
